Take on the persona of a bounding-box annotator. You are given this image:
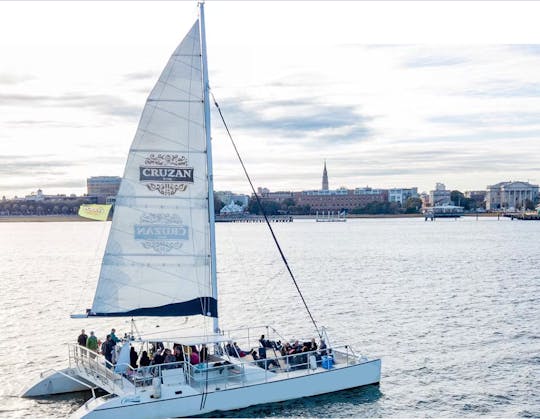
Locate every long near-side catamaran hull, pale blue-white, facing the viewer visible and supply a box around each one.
[73,359,381,419]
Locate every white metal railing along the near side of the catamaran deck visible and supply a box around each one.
[69,345,363,393]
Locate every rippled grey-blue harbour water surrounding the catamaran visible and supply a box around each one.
[0,218,540,417]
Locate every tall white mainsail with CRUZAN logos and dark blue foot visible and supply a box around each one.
[88,21,217,317]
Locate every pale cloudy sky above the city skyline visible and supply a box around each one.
[0,1,540,198]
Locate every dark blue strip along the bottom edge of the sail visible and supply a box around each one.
[88,297,217,317]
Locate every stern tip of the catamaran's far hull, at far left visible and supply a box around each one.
[21,368,94,397]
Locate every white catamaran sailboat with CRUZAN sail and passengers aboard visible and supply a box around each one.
[23,4,381,419]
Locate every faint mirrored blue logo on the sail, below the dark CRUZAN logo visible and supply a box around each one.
[134,213,189,254]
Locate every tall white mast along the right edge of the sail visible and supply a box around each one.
[199,2,219,333]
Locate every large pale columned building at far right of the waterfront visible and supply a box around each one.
[486,181,538,211]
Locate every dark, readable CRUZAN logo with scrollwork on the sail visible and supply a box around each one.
[139,154,194,196]
